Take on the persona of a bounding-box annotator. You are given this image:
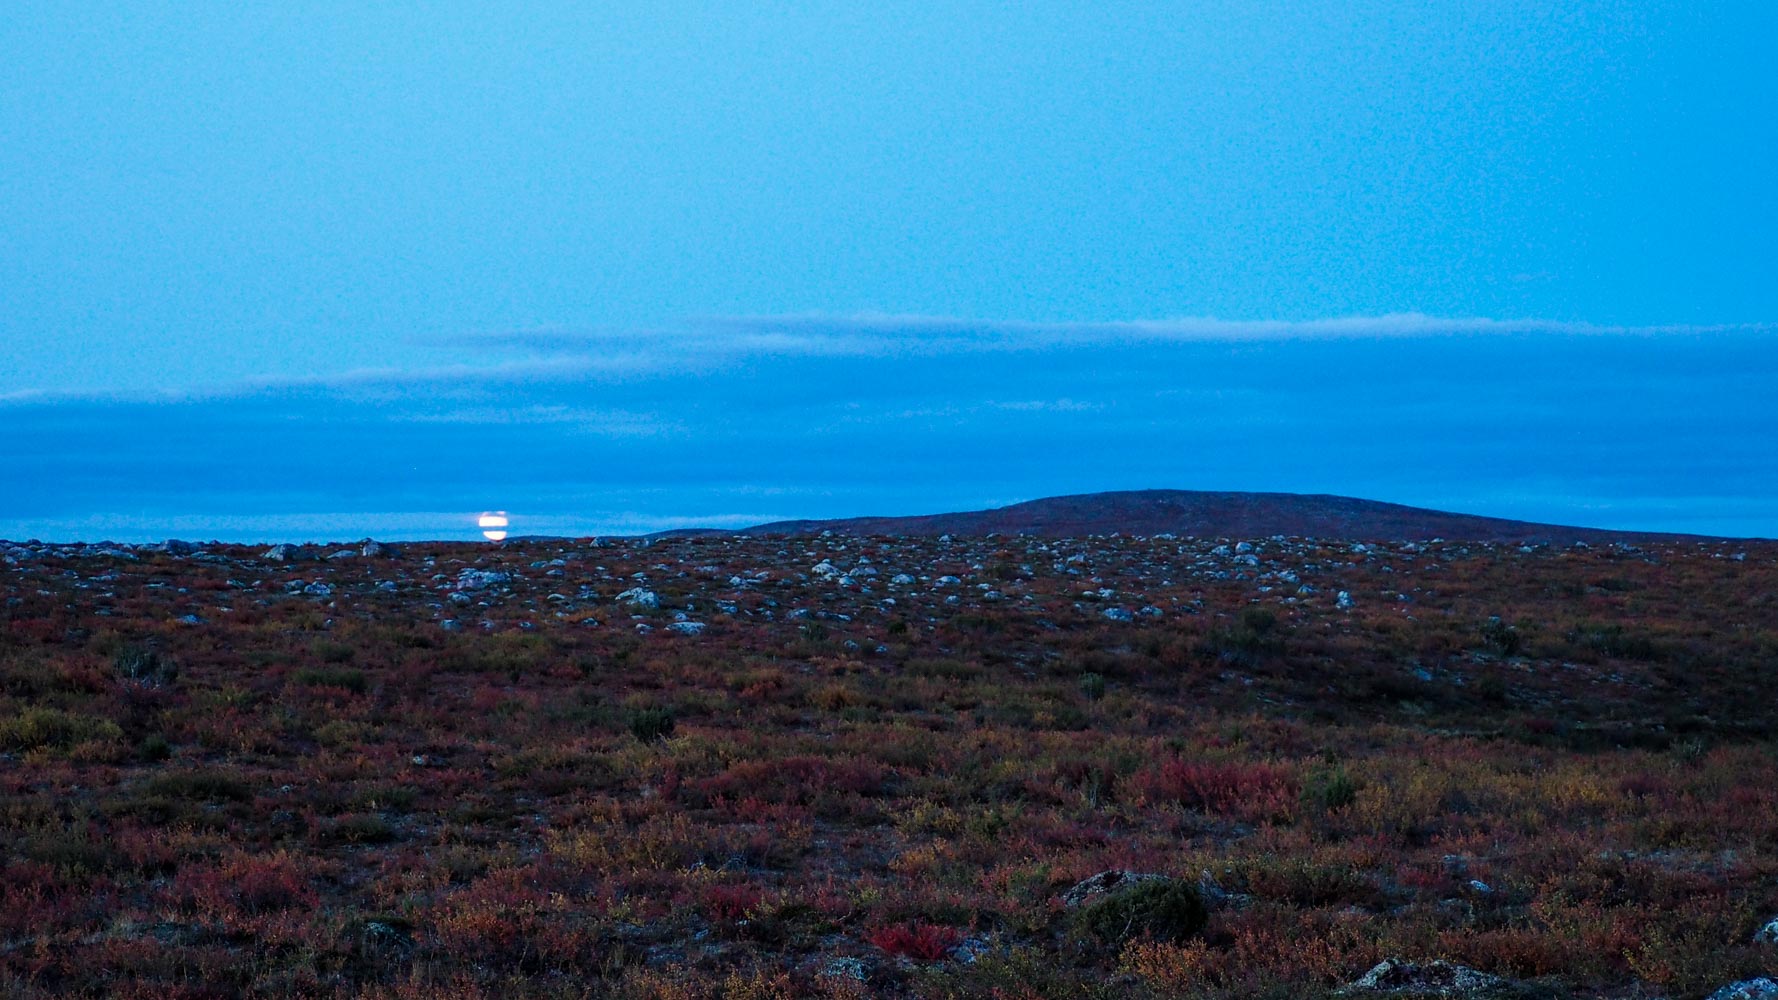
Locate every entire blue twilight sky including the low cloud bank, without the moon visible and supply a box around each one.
[0,0,1778,541]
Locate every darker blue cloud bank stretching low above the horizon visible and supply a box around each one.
[0,315,1778,537]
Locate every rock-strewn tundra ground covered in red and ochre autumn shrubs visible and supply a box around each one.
[0,534,1778,998]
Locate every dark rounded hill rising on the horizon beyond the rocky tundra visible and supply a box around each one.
[711,489,1721,543]
